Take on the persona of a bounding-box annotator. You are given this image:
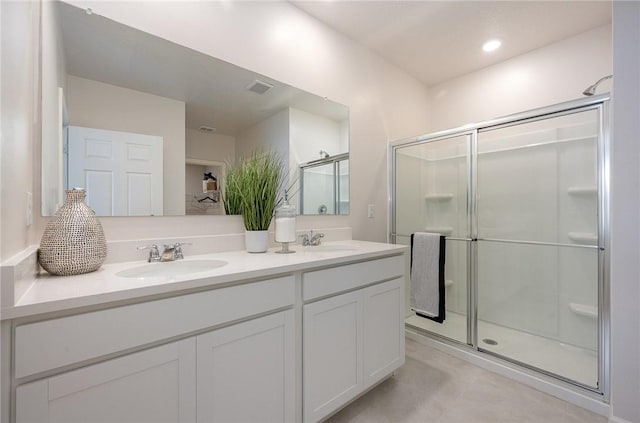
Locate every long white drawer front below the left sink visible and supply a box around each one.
[15,276,295,378]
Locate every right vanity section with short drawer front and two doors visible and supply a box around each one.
[303,256,404,422]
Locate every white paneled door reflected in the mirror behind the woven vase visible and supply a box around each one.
[67,126,163,216]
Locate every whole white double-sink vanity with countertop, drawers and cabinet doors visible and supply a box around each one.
[2,241,406,423]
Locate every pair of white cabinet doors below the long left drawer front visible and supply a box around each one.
[16,310,295,423]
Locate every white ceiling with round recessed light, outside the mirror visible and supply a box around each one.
[290,0,611,85]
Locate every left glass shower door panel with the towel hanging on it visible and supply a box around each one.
[392,134,471,343]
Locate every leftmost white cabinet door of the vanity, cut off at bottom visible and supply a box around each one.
[16,338,196,423]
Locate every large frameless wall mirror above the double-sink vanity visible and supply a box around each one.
[42,1,349,216]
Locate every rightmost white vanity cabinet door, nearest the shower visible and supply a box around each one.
[362,278,404,389]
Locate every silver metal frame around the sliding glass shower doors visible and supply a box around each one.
[388,94,610,402]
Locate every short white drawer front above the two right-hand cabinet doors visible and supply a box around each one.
[302,255,404,301]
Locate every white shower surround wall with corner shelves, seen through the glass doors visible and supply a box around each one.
[395,112,598,351]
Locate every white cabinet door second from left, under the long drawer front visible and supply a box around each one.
[197,310,295,422]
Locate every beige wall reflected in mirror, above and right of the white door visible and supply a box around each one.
[66,75,185,216]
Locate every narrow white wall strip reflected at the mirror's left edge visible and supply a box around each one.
[42,2,67,216]
